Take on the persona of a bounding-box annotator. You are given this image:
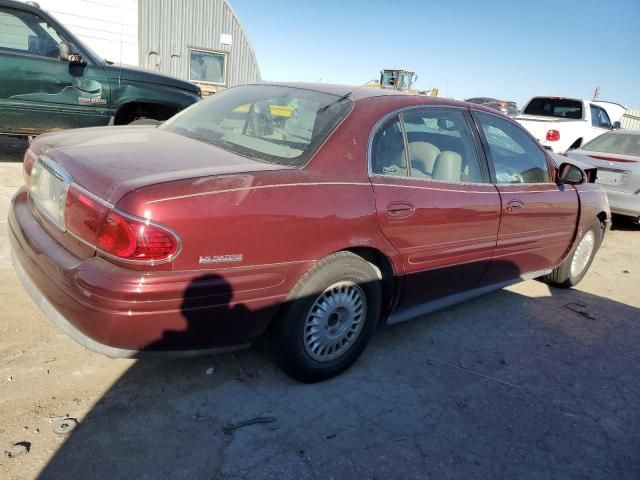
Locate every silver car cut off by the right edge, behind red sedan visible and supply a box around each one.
[566,130,640,219]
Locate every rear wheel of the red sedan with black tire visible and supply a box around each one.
[267,252,382,383]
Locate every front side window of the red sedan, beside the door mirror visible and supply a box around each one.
[474,112,551,184]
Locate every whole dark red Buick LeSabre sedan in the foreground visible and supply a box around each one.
[9,84,610,381]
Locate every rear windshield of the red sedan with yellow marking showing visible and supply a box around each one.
[159,85,351,166]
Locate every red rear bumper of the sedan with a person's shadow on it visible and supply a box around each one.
[8,190,283,357]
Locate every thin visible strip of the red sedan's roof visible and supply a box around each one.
[259,82,484,113]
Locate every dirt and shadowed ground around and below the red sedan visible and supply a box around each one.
[0,139,640,480]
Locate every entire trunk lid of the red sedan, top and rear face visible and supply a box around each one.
[25,127,290,259]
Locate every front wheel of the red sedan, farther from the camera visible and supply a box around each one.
[542,219,603,288]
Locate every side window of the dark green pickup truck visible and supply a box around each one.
[0,8,62,58]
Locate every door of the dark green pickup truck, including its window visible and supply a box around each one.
[0,7,111,135]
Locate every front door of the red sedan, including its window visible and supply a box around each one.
[473,111,579,283]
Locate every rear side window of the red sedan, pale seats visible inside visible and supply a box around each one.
[371,108,482,183]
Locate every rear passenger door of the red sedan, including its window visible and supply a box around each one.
[370,107,500,308]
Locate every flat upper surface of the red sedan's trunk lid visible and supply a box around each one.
[32,126,289,204]
